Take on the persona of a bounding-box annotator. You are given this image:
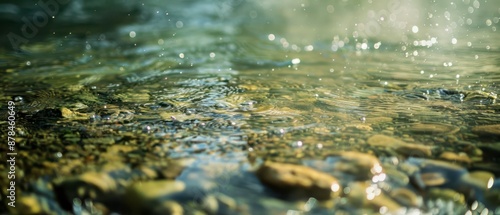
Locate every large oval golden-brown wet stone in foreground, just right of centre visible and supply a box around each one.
[256,162,342,200]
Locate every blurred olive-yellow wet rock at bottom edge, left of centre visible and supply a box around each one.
[124,180,186,214]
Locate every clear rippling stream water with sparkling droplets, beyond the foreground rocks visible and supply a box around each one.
[0,0,500,214]
